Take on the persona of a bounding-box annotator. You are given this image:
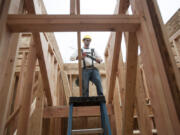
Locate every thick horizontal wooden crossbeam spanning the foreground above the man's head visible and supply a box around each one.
[7,15,140,32]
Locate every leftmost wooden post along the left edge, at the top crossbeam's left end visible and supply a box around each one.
[0,0,23,135]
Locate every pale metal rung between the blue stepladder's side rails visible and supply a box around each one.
[72,128,104,135]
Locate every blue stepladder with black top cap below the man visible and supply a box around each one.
[67,96,112,135]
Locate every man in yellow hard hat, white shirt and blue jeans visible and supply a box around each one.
[70,35,103,97]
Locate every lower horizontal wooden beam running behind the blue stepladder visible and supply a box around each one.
[44,104,113,118]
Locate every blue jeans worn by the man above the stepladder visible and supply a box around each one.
[82,68,103,97]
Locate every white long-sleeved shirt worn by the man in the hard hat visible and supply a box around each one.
[70,48,102,67]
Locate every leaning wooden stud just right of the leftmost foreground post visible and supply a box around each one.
[17,37,37,135]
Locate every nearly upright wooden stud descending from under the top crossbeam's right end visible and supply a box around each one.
[122,33,138,135]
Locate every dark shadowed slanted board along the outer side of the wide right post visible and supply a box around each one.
[147,1,180,120]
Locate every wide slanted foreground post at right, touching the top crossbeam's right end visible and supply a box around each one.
[131,0,180,135]
